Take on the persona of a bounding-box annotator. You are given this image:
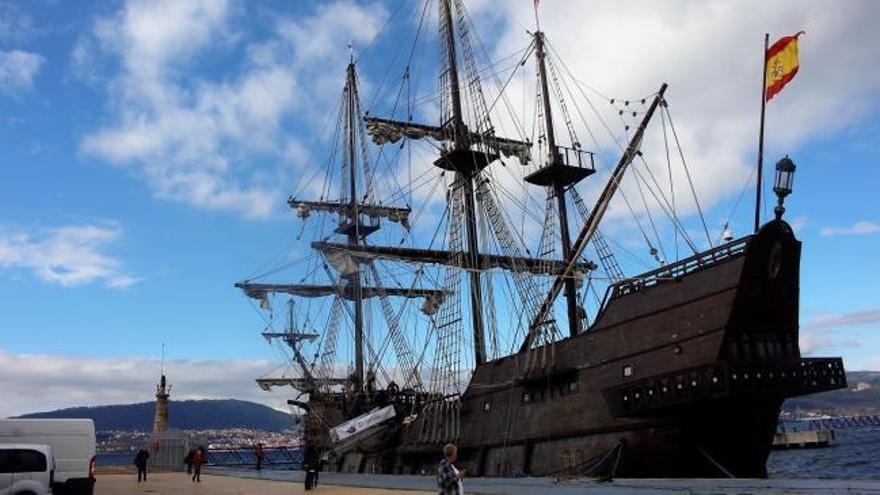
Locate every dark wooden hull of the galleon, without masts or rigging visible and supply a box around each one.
[306,221,846,477]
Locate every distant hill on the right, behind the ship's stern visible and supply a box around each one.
[783,371,880,416]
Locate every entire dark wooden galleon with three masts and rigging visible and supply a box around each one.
[236,0,846,477]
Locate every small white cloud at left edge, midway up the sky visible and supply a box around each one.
[0,223,140,289]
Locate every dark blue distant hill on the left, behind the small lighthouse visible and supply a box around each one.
[14,399,293,431]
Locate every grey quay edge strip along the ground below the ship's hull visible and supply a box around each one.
[209,468,880,495]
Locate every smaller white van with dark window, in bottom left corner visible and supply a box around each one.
[0,443,55,495]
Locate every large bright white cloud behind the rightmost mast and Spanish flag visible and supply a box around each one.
[469,0,880,241]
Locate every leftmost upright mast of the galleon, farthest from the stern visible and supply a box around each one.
[347,58,364,390]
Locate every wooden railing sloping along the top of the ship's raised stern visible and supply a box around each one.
[609,236,751,299]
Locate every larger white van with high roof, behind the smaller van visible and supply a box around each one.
[0,419,95,495]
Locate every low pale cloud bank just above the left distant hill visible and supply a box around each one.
[0,349,289,417]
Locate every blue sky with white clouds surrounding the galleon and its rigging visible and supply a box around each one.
[0,0,880,416]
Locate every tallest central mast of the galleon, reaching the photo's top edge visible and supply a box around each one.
[440,0,486,366]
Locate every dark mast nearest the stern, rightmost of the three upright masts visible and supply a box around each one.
[535,31,580,337]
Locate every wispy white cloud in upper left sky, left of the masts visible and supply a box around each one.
[74,0,386,218]
